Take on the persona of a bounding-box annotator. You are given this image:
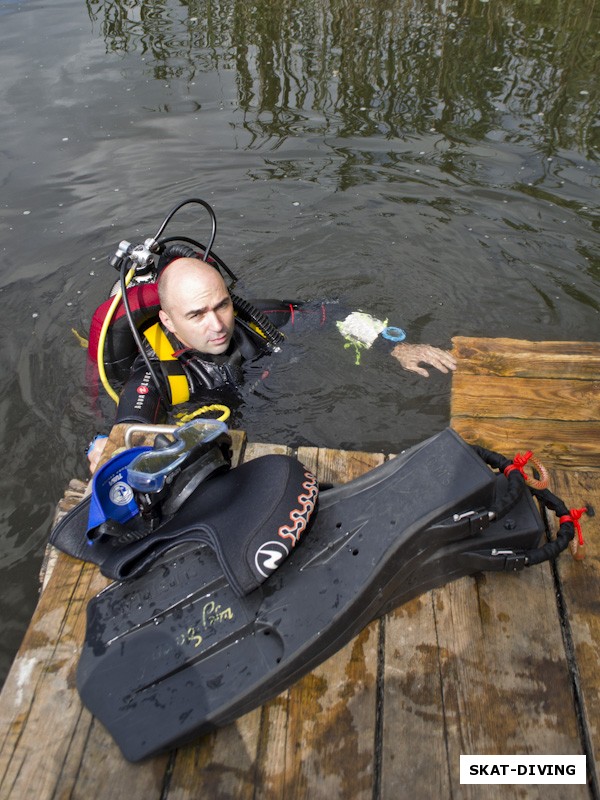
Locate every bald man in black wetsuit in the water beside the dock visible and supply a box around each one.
[88,257,456,472]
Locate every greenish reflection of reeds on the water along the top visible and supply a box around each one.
[87,0,600,161]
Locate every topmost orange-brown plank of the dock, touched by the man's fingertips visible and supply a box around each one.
[452,336,600,380]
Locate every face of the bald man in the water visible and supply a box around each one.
[160,267,235,355]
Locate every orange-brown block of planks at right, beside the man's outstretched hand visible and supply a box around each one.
[451,337,600,470]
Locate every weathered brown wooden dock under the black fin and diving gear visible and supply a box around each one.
[0,338,600,800]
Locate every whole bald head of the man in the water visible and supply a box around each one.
[158,258,234,355]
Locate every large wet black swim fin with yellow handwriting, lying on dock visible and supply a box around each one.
[77,429,543,761]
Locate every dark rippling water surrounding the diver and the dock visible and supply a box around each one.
[0,0,600,679]
